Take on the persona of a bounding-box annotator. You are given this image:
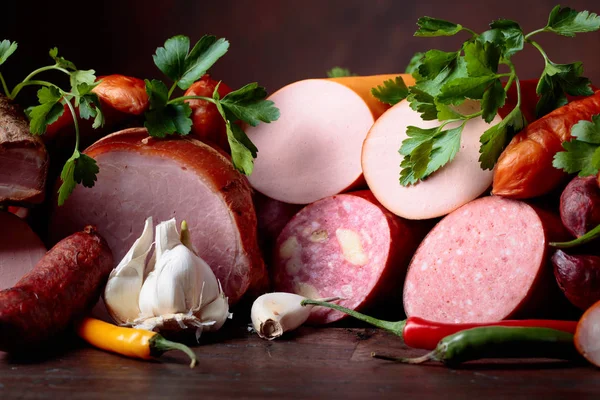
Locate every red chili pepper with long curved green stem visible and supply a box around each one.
[302,300,577,350]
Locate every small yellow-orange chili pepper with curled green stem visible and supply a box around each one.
[76,318,196,368]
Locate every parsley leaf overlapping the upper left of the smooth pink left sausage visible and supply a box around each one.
[220,82,279,126]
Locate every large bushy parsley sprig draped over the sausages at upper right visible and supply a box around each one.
[380,6,600,186]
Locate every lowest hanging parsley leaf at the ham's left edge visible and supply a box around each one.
[58,150,99,206]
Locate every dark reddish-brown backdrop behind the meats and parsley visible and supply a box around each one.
[0,0,600,96]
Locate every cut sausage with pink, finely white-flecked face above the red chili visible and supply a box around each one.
[404,196,567,323]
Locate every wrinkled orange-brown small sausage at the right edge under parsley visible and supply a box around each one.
[492,91,600,199]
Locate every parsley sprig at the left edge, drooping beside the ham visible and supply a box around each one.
[0,40,104,205]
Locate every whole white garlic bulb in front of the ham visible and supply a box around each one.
[104,219,231,337]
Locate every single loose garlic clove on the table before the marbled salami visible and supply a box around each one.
[250,292,338,340]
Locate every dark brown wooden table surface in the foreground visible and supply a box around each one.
[0,326,600,400]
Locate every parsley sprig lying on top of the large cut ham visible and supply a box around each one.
[144,35,279,175]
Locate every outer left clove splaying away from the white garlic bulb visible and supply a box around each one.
[104,217,153,324]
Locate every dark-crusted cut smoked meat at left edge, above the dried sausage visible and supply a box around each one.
[0,95,48,204]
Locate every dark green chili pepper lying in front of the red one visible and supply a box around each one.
[371,326,580,366]
